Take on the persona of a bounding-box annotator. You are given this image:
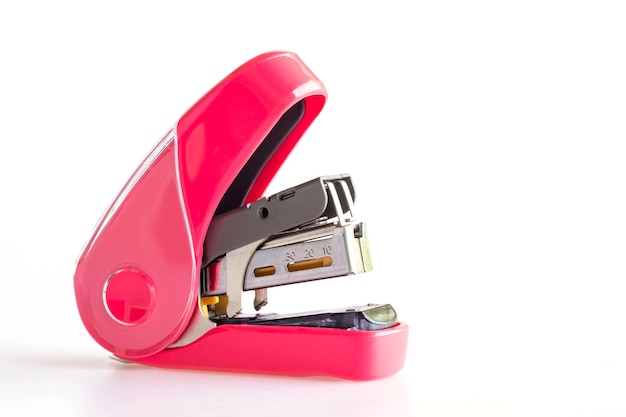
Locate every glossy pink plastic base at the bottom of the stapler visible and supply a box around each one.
[136,323,409,380]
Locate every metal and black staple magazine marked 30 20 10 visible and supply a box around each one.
[171,174,372,347]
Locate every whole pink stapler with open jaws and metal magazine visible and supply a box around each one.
[74,52,408,380]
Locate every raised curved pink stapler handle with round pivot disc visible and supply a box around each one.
[74,52,326,359]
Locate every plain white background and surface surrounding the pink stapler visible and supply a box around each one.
[0,0,626,417]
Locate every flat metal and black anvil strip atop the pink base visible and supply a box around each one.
[211,304,397,330]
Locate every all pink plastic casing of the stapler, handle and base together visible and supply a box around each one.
[74,52,408,379]
